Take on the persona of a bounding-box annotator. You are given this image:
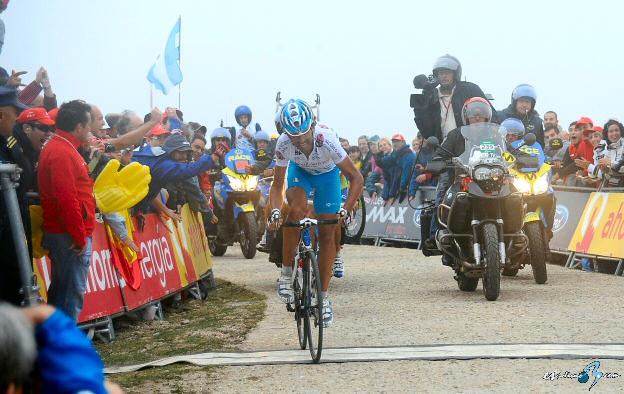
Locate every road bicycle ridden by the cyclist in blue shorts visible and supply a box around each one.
[282,218,338,363]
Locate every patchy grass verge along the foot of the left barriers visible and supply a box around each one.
[95,279,266,393]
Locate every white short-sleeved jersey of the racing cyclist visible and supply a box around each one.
[275,125,347,175]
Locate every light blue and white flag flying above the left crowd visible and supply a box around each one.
[147,18,182,94]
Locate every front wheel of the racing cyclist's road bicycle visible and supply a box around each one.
[303,251,323,363]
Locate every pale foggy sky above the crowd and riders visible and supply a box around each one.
[0,0,624,144]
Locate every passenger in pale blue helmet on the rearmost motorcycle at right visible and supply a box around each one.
[498,83,545,149]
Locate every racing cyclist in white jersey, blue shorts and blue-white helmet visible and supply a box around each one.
[268,100,364,327]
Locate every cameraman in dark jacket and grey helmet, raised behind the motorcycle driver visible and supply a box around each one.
[414,55,498,142]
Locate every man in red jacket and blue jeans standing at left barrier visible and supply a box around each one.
[38,100,95,321]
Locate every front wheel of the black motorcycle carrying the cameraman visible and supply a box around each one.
[481,223,501,301]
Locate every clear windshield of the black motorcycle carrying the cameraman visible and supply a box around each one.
[459,123,510,167]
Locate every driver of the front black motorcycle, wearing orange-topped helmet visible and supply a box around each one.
[425,97,492,266]
